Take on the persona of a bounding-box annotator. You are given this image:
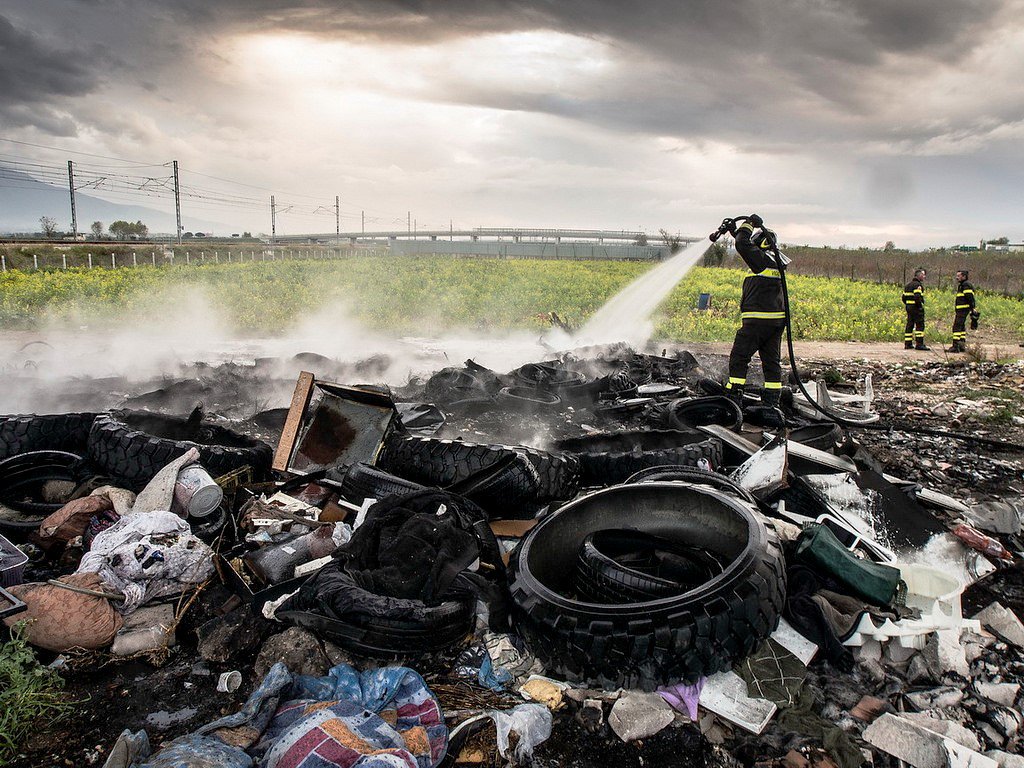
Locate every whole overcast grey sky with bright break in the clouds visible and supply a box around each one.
[0,0,1024,246]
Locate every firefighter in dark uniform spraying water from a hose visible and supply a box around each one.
[723,215,785,408]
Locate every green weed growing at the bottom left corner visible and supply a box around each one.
[0,623,73,765]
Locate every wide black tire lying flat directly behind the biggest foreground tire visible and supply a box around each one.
[556,429,722,486]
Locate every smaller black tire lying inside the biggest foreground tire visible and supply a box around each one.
[573,529,722,603]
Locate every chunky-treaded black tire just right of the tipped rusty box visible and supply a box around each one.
[377,436,580,503]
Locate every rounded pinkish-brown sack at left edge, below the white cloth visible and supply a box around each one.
[4,573,124,652]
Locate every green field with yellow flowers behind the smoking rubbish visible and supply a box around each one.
[0,256,1024,341]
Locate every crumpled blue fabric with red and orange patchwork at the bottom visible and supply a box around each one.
[104,663,448,768]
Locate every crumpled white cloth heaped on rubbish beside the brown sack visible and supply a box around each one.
[76,512,214,613]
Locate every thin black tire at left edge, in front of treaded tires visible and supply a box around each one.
[0,451,88,540]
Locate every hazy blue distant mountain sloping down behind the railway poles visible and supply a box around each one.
[0,164,231,234]
